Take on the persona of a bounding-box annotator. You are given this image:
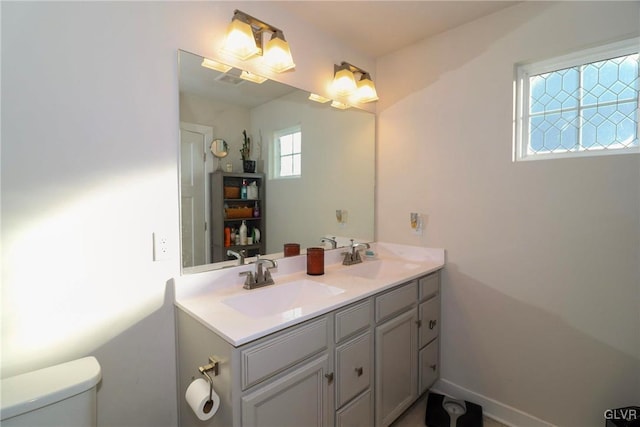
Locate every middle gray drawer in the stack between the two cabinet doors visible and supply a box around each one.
[336,332,373,408]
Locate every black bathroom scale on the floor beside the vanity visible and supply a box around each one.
[424,392,483,427]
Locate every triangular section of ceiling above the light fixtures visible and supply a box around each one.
[275,0,519,59]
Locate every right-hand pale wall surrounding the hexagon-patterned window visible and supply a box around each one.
[376,2,640,427]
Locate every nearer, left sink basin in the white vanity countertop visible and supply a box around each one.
[222,279,344,318]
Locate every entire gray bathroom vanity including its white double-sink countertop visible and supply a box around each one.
[175,243,444,427]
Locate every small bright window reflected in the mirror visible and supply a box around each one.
[273,126,302,178]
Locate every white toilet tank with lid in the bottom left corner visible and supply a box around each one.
[0,357,101,427]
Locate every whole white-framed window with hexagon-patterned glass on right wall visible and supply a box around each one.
[514,39,640,160]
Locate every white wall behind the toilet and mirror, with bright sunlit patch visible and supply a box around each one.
[0,2,373,427]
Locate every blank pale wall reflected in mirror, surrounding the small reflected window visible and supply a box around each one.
[251,92,375,253]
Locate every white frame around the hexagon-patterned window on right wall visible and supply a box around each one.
[513,37,640,161]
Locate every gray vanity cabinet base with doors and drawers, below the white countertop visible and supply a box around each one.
[176,272,440,427]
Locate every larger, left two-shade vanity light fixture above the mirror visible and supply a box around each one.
[222,10,296,73]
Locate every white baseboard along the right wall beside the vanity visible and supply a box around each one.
[431,379,553,427]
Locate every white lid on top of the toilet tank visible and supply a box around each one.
[0,357,102,420]
